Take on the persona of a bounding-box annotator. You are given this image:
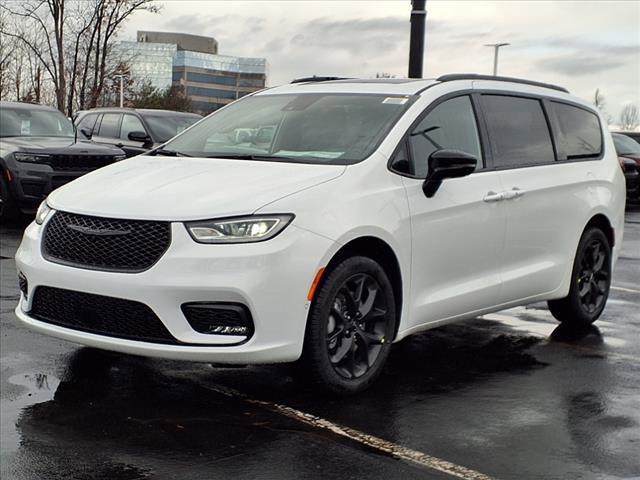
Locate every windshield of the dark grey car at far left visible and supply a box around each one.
[0,106,74,137]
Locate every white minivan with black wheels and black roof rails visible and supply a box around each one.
[16,74,625,393]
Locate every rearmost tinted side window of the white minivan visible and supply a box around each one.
[552,102,602,160]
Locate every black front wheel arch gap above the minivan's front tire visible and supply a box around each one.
[314,235,404,339]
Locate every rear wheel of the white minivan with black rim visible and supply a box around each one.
[548,227,611,327]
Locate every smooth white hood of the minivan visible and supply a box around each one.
[48,156,346,221]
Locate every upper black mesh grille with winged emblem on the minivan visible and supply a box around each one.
[42,212,171,273]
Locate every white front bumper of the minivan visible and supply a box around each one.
[16,218,336,364]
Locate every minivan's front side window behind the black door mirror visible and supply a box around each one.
[409,96,482,177]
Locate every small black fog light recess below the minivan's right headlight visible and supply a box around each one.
[181,302,253,338]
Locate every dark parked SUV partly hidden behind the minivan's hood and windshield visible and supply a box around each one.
[74,108,202,157]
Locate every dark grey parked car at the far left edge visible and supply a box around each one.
[0,102,125,221]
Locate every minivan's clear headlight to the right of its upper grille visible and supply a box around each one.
[185,214,294,243]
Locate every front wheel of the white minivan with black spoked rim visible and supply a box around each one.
[301,256,396,395]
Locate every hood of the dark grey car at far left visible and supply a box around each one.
[0,137,122,155]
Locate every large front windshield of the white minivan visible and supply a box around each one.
[158,93,410,165]
